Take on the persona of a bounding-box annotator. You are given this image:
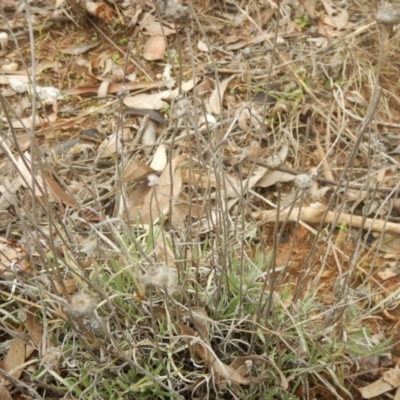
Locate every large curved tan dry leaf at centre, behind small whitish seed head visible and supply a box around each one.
[130,155,186,224]
